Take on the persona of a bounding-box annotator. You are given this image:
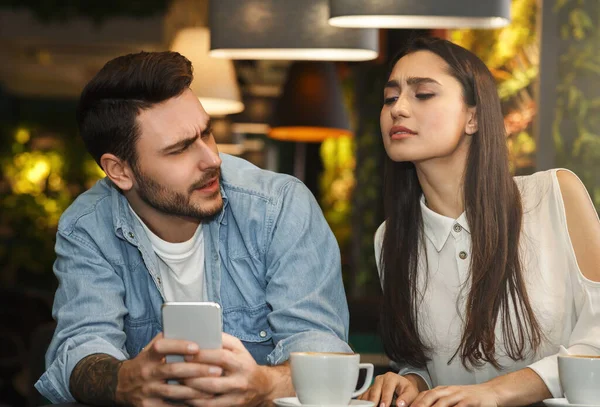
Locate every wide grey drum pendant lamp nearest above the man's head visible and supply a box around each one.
[209,0,378,61]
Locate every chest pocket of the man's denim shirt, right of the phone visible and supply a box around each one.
[223,304,275,365]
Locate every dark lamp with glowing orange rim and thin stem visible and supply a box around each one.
[268,61,352,180]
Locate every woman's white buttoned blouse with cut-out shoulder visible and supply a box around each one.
[375,170,600,397]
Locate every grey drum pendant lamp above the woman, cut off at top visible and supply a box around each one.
[329,0,511,28]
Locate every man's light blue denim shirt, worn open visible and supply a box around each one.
[35,154,351,403]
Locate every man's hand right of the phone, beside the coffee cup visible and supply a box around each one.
[183,333,293,407]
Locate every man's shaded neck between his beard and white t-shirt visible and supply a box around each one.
[127,196,200,243]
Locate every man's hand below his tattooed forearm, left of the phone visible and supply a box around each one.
[115,333,222,407]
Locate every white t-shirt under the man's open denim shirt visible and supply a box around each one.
[129,206,206,302]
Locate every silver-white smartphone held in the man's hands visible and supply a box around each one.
[162,302,223,363]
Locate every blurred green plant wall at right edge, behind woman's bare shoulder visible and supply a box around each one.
[552,0,600,211]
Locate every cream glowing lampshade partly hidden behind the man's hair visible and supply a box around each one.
[171,27,244,116]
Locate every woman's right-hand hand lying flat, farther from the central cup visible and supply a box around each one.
[412,383,500,407]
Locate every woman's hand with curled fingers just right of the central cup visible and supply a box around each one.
[359,372,424,407]
